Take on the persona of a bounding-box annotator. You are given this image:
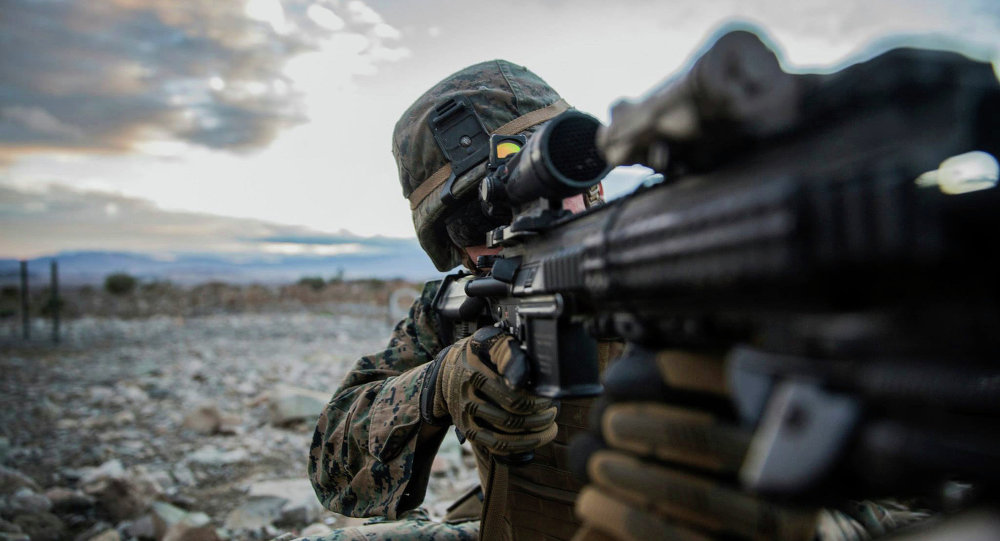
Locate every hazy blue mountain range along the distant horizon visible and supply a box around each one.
[0,242,440,285]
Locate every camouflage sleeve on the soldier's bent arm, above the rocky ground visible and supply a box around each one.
[309,281,444,520]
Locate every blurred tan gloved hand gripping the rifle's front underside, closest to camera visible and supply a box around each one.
[571,351,817,541]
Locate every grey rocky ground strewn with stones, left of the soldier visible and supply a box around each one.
[0,304,475,541]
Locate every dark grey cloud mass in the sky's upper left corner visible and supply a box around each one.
[0,0,340,154]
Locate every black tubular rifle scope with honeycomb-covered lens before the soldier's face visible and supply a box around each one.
[498,111,611,205]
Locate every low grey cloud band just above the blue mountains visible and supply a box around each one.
[0,185,400,257]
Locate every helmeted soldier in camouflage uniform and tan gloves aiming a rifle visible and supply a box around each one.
[309,60,928,541]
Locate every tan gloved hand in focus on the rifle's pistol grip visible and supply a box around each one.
[423,327,557,456]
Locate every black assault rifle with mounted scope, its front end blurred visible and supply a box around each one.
[437,32,1000,500]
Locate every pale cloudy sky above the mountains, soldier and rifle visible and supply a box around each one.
[0,0,1000,257]
